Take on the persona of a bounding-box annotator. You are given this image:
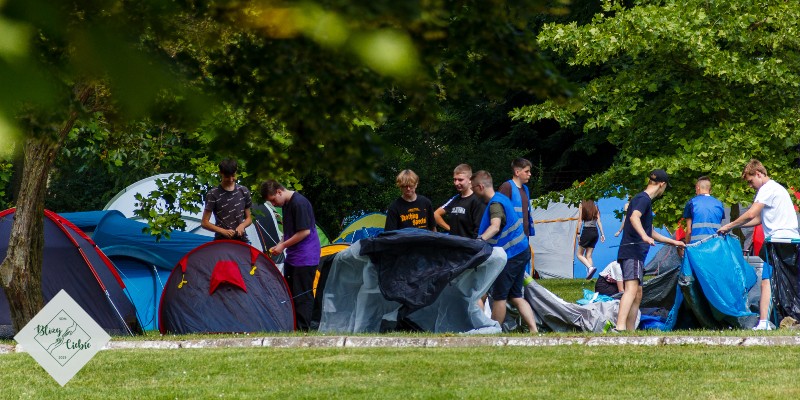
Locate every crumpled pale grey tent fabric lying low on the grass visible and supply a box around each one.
[523,280,639,332]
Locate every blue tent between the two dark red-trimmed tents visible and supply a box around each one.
[93,211,213,330]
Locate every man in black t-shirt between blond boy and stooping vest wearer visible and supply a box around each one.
[433,164,486,239]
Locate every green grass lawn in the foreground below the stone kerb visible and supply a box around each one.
[0,346,800,399]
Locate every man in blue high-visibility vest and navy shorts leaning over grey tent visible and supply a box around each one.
[472,171,538,333]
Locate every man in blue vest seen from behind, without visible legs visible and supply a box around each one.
[683,176,725,243]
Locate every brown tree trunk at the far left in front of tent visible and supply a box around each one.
[0,87,91,332]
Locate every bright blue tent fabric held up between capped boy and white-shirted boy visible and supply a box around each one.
[681,235,757,318]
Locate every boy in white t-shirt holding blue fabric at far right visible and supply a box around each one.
[718,159,800,330]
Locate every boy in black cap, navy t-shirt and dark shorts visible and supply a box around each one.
[615,169,685,331]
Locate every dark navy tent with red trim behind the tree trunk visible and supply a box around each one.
[0,209,141,338]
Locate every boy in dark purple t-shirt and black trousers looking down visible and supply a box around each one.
[261,180,320,330]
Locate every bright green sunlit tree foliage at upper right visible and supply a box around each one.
[511,0,800,223]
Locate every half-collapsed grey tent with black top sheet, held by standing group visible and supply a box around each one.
[319,229,506,333]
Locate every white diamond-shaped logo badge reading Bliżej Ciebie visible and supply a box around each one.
[14,290,111,386]
